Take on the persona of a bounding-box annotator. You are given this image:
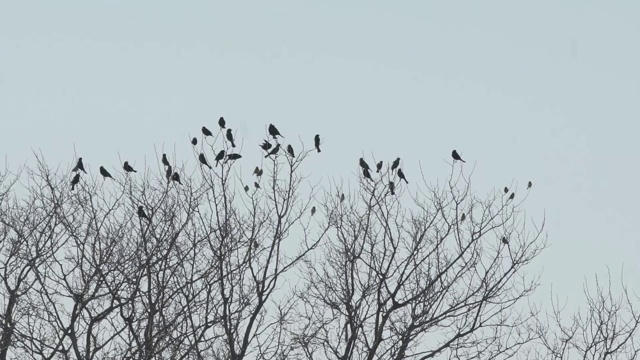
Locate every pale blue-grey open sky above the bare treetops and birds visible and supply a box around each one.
[0,0,640,310]
